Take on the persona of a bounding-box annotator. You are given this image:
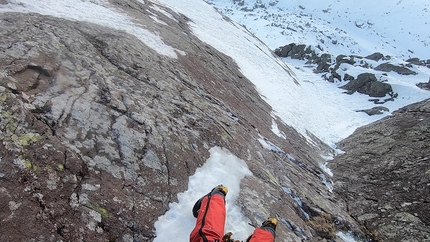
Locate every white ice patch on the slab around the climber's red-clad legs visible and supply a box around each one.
[154,147,253,242]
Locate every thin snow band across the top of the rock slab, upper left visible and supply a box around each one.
[0,0,177,58]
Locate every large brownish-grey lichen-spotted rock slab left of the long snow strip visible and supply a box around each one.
[0,0,367,241]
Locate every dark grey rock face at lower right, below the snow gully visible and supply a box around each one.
[330,100,430,241]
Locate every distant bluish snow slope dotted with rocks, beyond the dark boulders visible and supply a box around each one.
[207,0,430,59]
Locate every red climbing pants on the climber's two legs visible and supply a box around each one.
[190,194,275,242]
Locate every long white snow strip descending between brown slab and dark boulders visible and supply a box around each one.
[146,0,430,147]
